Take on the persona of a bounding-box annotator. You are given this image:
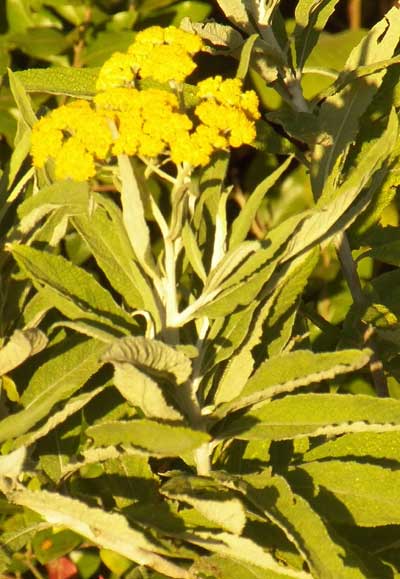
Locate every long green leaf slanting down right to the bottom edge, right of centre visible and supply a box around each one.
[234,472,364,579]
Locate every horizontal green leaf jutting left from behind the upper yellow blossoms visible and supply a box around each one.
[14,66,100,98]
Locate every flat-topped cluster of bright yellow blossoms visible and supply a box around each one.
[32,26,259,181]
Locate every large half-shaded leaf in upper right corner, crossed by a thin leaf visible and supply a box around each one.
[311,7,400,197]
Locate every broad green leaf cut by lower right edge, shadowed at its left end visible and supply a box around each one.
[291,460,400,527]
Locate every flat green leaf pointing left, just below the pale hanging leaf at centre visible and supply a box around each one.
[86,420,209,456]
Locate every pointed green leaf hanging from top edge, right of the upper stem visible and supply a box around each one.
[294,0,338,70]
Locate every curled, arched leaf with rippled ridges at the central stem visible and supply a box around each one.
[103,336,192,384]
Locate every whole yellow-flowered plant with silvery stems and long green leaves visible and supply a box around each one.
[0,1,400,579]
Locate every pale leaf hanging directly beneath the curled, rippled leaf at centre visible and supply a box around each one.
[114,362,182,421]
